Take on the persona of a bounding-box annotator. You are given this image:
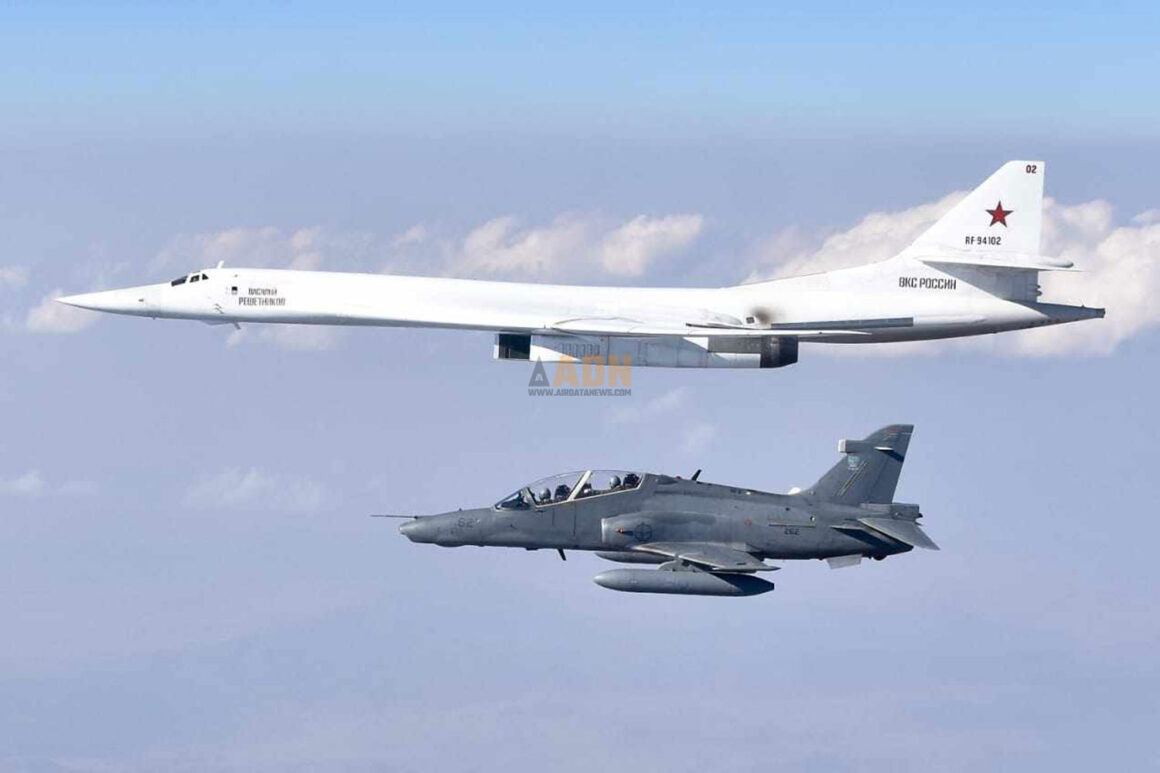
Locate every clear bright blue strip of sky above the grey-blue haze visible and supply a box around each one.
[0,2,1160,139]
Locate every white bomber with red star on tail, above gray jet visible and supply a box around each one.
[58,161,1103,368]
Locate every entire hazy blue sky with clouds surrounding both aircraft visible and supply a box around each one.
[0,2,1160,772]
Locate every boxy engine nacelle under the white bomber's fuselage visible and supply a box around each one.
[495,333,798,368]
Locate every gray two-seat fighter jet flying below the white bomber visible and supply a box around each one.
[399,424,938,595]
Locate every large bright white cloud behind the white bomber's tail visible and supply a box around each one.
[749,193,1160,355]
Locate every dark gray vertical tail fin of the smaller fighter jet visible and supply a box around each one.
[804,424,914,505]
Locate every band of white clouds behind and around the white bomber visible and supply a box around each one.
[15,193,1160,355]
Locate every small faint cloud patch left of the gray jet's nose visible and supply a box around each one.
[184,468,326,512]
